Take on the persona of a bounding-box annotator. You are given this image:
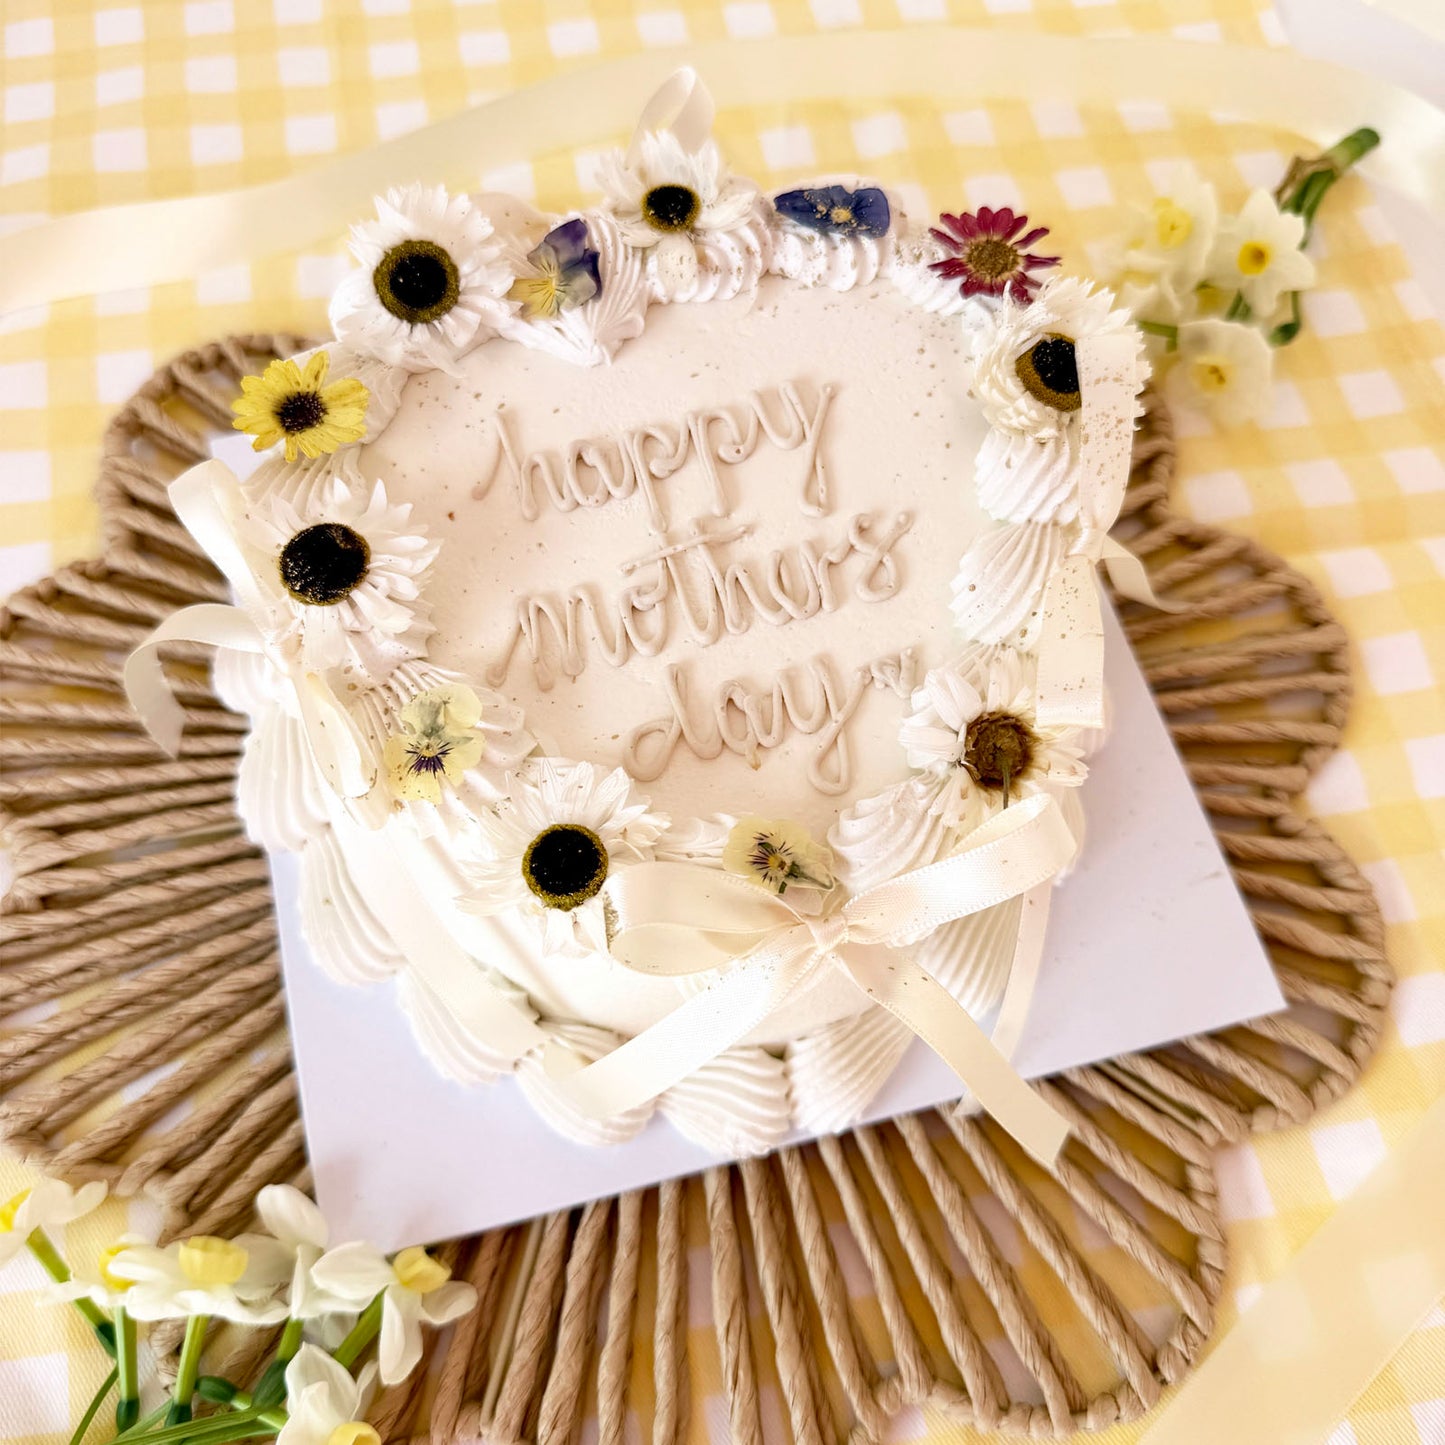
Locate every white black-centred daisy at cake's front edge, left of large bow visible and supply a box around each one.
[464,759,668,954]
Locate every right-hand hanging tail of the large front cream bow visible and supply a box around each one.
[840,949,1069,1170]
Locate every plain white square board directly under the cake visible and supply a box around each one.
[272,604,1285,1250]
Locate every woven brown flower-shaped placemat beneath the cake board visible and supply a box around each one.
[0,335,1390,1445]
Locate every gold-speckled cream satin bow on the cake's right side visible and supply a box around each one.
[1035,335,1182,728]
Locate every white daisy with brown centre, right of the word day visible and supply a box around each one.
[899,647,1088,832]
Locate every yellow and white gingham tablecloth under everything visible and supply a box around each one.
[0,0,1445,1445]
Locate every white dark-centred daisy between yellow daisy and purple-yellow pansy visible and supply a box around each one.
[331,184,512,371]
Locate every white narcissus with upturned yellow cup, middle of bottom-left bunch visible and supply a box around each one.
[107,1234,290,1325]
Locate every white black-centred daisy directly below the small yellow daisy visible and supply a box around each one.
[241,478,438,673]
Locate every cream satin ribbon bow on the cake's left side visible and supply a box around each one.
[123,461,376,798]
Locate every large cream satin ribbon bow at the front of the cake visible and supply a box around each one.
[546,793,1075,1168]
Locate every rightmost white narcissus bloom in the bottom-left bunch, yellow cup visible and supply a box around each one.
[314,1244,477,1384]
